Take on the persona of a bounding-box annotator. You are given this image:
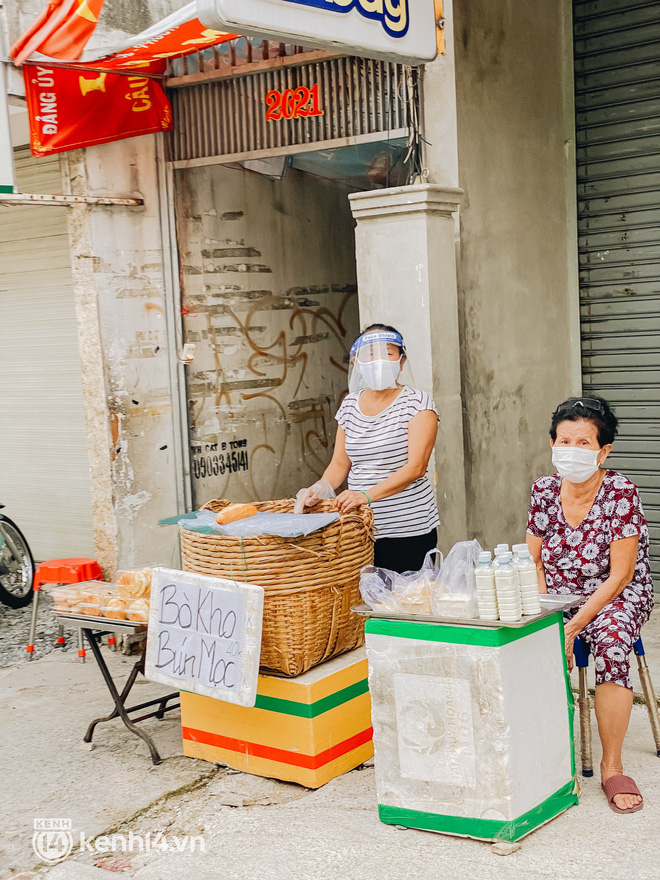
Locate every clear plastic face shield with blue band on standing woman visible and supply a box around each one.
[348,330,408,392]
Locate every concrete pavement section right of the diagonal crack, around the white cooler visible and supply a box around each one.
[40,706,660,880]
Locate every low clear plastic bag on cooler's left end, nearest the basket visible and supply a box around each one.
[360,550,442,614]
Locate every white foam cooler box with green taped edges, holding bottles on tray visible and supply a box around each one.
[366,612,578,841]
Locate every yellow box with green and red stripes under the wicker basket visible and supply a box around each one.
[181,648,374,788]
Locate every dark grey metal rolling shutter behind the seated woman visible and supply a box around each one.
[574,0,660,584]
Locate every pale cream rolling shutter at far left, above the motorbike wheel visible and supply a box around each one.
[0,151,94,560]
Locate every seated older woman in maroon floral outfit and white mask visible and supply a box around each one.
[527,397,653,813]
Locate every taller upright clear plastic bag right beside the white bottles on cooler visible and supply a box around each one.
[431,541,481,619]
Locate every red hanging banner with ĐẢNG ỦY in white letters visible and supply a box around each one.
[23,64,172,156]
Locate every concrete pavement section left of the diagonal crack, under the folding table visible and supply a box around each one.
[0,648,213,877]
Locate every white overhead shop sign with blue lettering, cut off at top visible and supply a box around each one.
[197,0,437,64]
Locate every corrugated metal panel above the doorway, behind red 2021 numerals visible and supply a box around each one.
[168,56,410,168]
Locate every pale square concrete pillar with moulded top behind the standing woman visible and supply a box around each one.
[349,184,469,552]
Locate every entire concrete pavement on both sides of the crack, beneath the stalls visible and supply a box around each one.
[0,618,660,880]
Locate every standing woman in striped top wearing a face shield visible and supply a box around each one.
[299,324,439,572]
